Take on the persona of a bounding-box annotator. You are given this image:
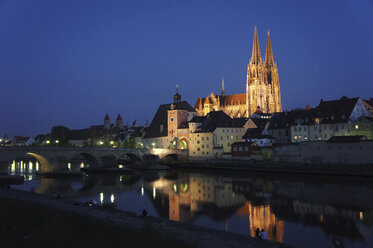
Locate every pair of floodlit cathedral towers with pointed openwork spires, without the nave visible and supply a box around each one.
[246,26,282,117]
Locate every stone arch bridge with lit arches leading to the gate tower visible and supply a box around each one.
[0,146,188,172]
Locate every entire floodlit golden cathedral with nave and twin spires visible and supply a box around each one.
[194,26,282,118]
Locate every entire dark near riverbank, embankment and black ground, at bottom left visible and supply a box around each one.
[0,189,286,248]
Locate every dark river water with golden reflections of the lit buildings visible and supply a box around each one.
[8,160,373,248]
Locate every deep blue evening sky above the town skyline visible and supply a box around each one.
[0,0,373,136]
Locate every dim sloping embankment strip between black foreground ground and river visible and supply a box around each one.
[0,189,287,248]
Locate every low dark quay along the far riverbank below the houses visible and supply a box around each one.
[165,160,373,177]
